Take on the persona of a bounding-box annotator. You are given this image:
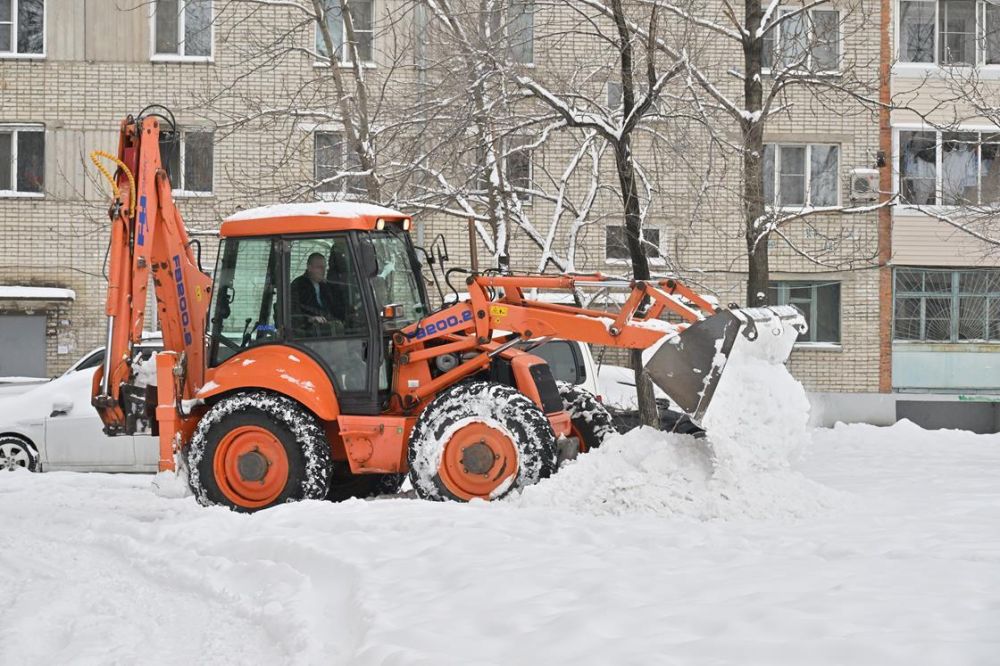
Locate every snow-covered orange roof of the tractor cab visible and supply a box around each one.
[219,201,410,238]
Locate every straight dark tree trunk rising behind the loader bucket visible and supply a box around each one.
[740,0,770,307]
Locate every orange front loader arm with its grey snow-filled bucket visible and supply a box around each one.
[395,274,805,421]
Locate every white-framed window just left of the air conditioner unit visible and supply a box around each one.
[764,143,840,208]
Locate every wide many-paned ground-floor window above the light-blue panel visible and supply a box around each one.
[893,268,1000,342]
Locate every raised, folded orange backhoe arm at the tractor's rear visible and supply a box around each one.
[93,115,212,434]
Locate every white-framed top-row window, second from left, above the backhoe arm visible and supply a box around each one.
[153,0,212,59]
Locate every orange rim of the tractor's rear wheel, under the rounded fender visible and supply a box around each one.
[212,426,288,509]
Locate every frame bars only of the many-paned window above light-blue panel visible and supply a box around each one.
[892,266,1000,345]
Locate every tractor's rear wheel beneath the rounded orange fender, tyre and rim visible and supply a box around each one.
[188,391,330,512]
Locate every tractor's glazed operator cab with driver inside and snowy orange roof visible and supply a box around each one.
[208,203,429,414]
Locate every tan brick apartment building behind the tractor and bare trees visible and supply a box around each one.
[0,0,1000,420]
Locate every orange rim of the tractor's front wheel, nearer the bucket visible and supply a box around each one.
[438,422,517,500]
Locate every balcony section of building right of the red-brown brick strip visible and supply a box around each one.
[887,0,1000,431]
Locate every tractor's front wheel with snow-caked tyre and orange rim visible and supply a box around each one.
[409,381,556,502]
